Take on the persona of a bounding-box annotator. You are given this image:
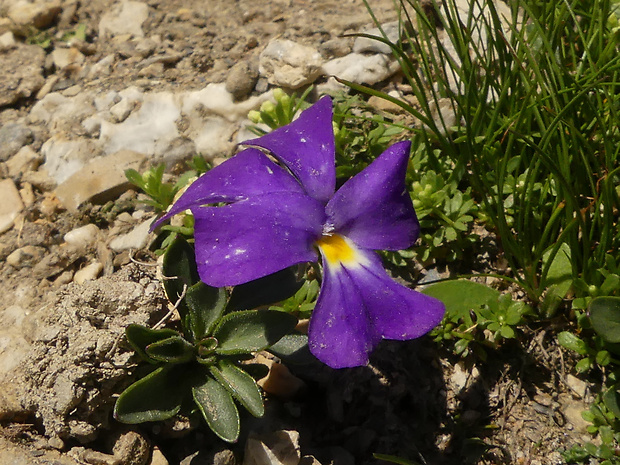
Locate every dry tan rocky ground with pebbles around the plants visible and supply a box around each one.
[0,0,591,465]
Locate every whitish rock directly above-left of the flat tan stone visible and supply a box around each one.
[41,133,101,184]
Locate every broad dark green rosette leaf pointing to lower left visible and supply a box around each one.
[114,365,185,424]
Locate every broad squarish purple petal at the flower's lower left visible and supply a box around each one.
[192,192,325,287]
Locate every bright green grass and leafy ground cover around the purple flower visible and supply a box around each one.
[124,0,620,458]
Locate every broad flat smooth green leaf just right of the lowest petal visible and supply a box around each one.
[422,280,500,319]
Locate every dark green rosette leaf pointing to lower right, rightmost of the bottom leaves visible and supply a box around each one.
[209,359,265,417]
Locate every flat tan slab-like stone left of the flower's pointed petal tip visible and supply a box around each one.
[55,150,145,211]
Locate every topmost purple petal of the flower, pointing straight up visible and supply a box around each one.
[244,97,336,204]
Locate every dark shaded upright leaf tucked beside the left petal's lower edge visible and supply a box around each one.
[162,237,200,329]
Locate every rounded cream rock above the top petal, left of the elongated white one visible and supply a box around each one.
[258,39,323,89]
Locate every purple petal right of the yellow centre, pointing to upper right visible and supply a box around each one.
[326,141,420,250]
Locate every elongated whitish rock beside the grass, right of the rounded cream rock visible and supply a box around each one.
[323,53,400,85]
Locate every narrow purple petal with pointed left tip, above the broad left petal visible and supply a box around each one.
[153,148,304,228]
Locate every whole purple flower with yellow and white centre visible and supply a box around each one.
[159,97,444,368]
